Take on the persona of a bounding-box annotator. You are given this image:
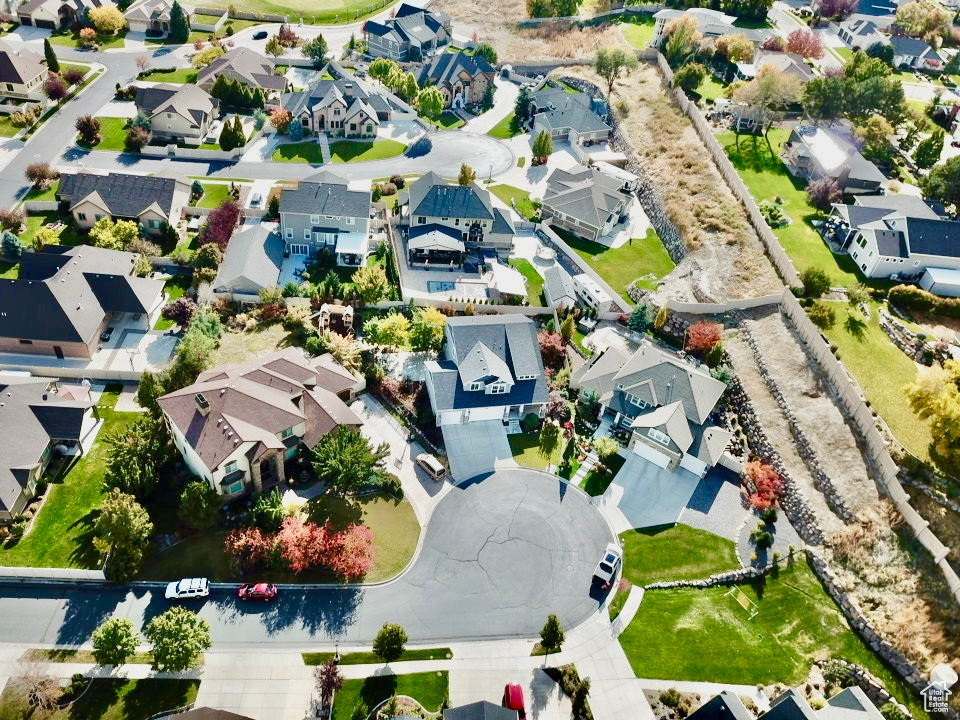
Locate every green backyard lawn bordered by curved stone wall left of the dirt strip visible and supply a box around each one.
[553,227,674,302]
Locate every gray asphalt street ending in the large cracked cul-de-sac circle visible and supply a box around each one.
[0,469,613,649]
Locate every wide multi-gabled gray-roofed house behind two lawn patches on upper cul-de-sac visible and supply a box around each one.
[280,79,394,139]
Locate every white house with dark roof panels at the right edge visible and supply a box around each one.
[827,195,960,278]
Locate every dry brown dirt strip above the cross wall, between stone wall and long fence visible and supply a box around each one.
[556,63,783,301]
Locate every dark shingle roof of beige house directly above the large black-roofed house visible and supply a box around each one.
[57,172,178,218]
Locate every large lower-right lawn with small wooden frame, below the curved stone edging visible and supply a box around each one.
[620,560,927,718]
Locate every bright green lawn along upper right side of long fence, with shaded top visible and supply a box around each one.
[717,128,859,287]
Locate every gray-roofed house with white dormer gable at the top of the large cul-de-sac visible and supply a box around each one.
[426,315,548,428]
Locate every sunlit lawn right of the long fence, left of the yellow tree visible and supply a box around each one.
[824,302,930,458]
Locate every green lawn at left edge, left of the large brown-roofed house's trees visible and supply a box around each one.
[0,392,138,569]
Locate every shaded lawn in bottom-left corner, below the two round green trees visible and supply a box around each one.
[0,678,200,720]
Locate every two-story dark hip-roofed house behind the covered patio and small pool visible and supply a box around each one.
[408,172,516,251]
